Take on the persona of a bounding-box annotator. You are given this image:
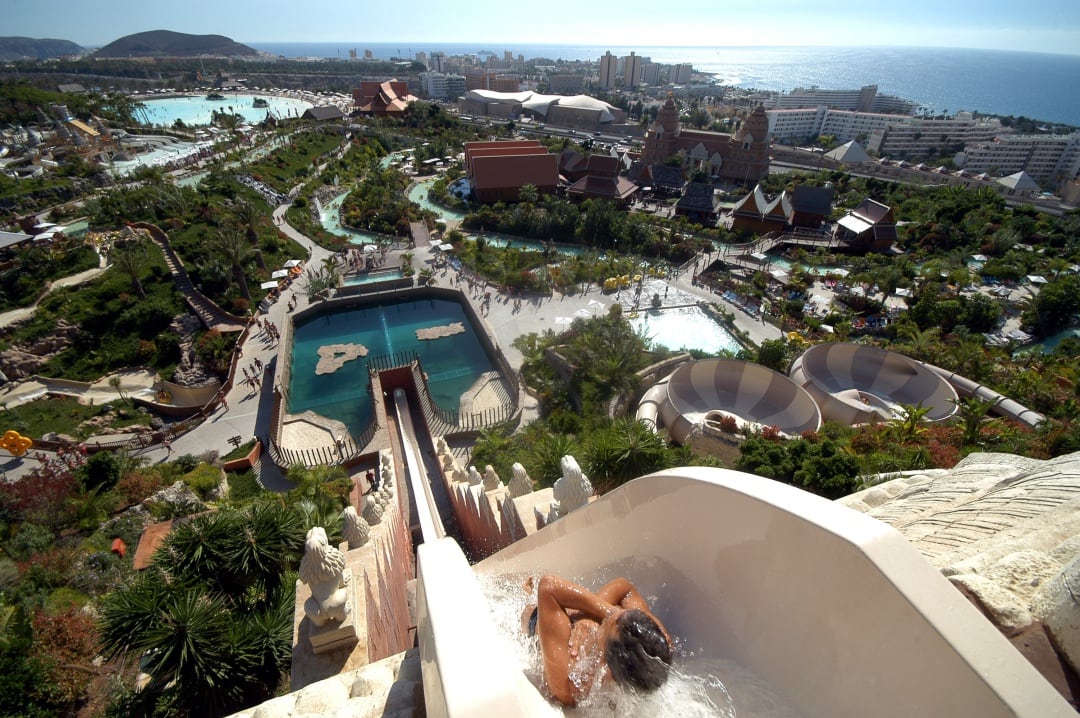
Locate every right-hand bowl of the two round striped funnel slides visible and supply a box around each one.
[788,342,958,425]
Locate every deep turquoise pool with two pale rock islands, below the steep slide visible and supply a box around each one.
[288,298,495,437]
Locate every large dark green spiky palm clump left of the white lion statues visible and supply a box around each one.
[99,503,303,715]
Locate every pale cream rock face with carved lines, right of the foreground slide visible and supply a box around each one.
[839,452,1080,669]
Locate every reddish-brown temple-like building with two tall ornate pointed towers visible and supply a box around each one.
[642,97,769,185]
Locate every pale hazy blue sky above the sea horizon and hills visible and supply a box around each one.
[8,0,1080,54]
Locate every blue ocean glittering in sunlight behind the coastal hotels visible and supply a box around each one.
[245,41,1080,126]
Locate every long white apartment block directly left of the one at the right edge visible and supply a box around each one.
[866,112,1012,160]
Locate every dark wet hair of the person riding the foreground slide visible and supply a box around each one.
[605,608,672,691]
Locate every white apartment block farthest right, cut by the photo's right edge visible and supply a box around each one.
[956,132,1080,188]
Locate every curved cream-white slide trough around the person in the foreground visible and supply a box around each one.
[417,466,1075,718]
